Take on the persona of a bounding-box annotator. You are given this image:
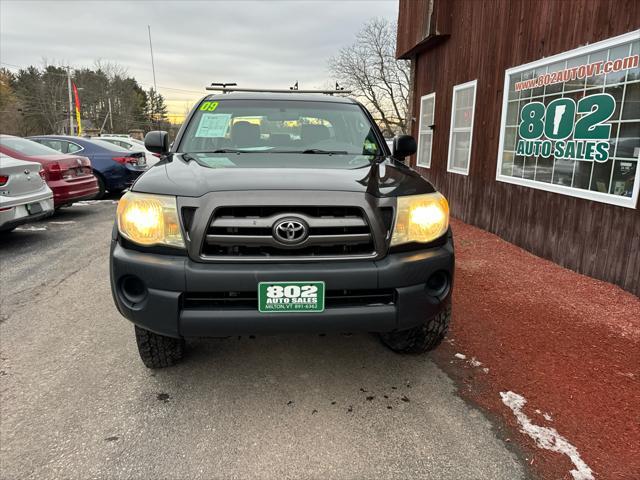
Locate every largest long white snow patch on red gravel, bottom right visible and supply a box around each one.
[500,391,594,480]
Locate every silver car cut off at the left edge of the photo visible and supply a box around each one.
[0,153,53,232]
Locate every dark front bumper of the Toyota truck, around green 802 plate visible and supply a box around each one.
[110,233,454,337]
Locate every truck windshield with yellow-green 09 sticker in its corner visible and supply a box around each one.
[179,99,383,156]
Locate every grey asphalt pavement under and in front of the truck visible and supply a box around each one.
[0,199,528,480]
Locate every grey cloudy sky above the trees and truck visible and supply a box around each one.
[0,0,398,120]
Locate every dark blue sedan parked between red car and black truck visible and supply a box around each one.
[30,135,149,198]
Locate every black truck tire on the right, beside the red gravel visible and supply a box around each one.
[380,307,451,353]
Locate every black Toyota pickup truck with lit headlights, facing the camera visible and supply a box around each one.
[110,92,454,368]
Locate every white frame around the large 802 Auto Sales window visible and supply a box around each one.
[496,30,640,209]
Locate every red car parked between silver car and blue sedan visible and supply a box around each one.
[0,135,99,208]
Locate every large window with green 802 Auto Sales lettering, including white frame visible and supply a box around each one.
[496,31,640,208]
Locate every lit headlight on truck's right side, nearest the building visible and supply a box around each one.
[391,192,449,247]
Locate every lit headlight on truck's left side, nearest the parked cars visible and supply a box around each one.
[118,192,185,248]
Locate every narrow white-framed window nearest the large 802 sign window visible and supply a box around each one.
[447,80,478,175]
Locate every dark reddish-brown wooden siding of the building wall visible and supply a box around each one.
[398,0,640,295]
